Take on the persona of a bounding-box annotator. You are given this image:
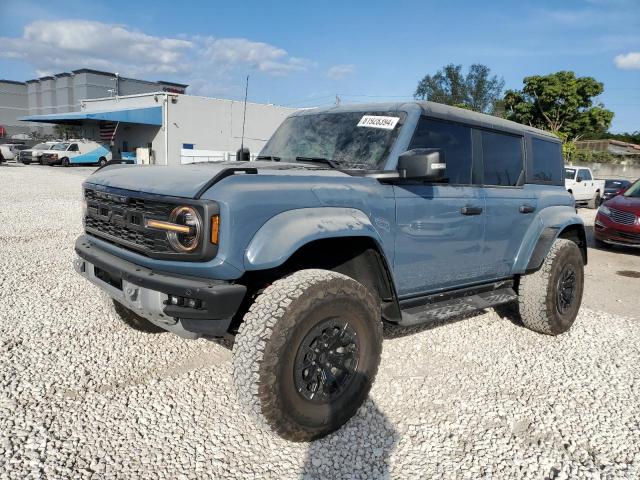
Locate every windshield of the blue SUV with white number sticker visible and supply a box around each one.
[260,112,406,170]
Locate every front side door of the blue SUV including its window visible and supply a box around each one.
[394,117,485,297]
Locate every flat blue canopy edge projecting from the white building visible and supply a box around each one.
[18,107,162,126]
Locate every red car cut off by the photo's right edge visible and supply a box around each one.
[594,179,640,247]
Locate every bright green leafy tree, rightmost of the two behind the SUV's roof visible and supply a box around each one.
[504,72,613,142]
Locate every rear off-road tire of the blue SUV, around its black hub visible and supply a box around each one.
[518,238,584,335]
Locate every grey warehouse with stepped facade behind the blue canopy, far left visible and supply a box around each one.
[0,68,188,136]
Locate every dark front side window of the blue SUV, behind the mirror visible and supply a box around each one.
[409,117,471,185]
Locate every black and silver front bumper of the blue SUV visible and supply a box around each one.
[74,235,247,338]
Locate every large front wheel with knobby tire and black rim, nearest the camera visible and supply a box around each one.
[233,269,382,442]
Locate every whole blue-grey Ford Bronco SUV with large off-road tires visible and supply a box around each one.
[75,102,587,441]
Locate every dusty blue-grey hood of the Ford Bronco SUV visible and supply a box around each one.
[85,161,348,198]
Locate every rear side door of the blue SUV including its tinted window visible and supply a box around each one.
[476,130,537,278]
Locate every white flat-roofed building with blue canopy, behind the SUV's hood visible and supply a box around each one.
[21,92,295,165]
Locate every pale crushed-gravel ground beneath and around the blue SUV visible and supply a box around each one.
[0,164,640,479]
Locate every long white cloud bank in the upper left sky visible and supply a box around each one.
[0,20,315,80]
